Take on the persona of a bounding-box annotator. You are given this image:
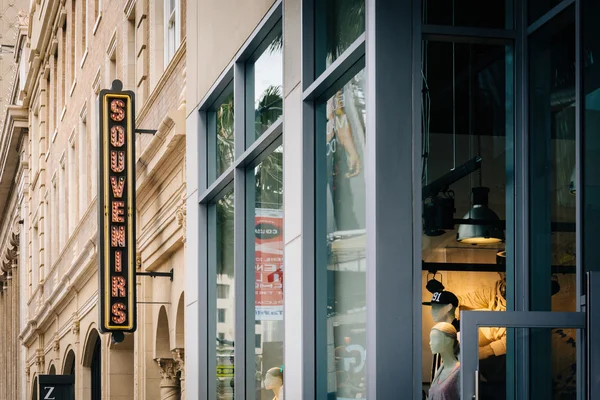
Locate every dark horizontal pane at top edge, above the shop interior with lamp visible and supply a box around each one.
[423,0,513,29]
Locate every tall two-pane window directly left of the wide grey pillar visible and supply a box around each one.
[310,0,366,399]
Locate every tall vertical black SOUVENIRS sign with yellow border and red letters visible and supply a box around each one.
[98,80,136,333]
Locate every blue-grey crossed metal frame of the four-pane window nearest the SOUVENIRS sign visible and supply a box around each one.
[196,0,283,400]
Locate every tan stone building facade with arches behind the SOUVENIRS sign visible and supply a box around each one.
[5,0,186,400]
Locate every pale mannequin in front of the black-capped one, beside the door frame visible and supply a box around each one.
[429,322,460,400]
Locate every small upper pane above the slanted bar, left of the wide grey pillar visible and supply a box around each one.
[315,0,365,75]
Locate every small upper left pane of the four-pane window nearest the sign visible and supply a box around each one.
[207,90,234,183]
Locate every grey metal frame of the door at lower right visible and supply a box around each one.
[460,311,586,399]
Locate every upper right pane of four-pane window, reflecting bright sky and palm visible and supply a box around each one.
[246,27,283,146]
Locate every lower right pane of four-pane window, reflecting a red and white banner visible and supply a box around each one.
[249,147,284,400]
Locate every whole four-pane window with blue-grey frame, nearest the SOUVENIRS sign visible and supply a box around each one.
[202,10,285,400]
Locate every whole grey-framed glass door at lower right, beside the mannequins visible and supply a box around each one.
[458,311,586,400]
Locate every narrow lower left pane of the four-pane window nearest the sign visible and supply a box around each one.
[215,191,235,400]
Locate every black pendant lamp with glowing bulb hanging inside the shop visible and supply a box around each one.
[456,186,504,245]
